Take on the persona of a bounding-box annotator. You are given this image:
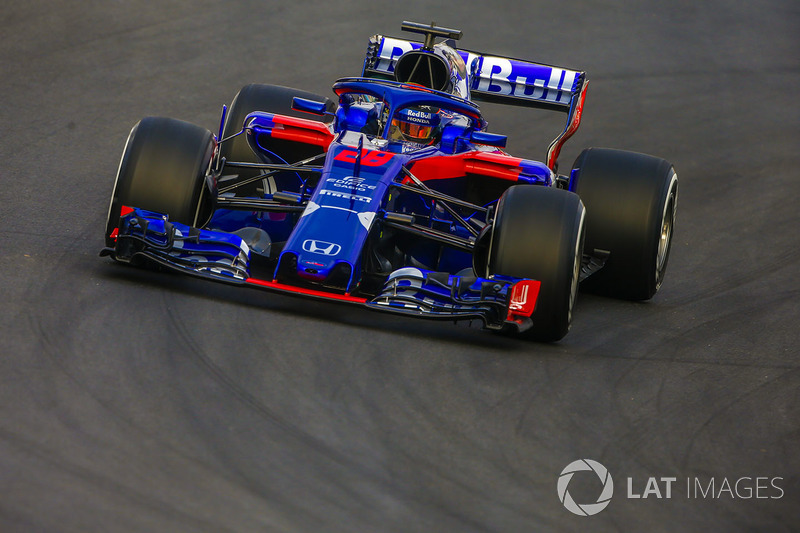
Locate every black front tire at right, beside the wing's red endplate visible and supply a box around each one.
[487,185,584,342]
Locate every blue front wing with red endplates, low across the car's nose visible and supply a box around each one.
[101,207,540,331]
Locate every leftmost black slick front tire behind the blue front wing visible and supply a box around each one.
[106,117,215,247]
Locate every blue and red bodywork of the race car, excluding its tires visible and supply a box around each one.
[104,28,583,329]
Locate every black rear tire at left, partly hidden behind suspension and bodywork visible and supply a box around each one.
[219,83,336,196]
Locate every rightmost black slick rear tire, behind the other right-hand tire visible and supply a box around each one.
[571,148,678,300]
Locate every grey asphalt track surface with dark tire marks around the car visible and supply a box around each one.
[0,0,800,532]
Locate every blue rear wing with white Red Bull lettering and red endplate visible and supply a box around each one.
[362,35,588,171]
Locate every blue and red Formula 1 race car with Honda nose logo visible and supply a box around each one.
[101,22,678,341]
